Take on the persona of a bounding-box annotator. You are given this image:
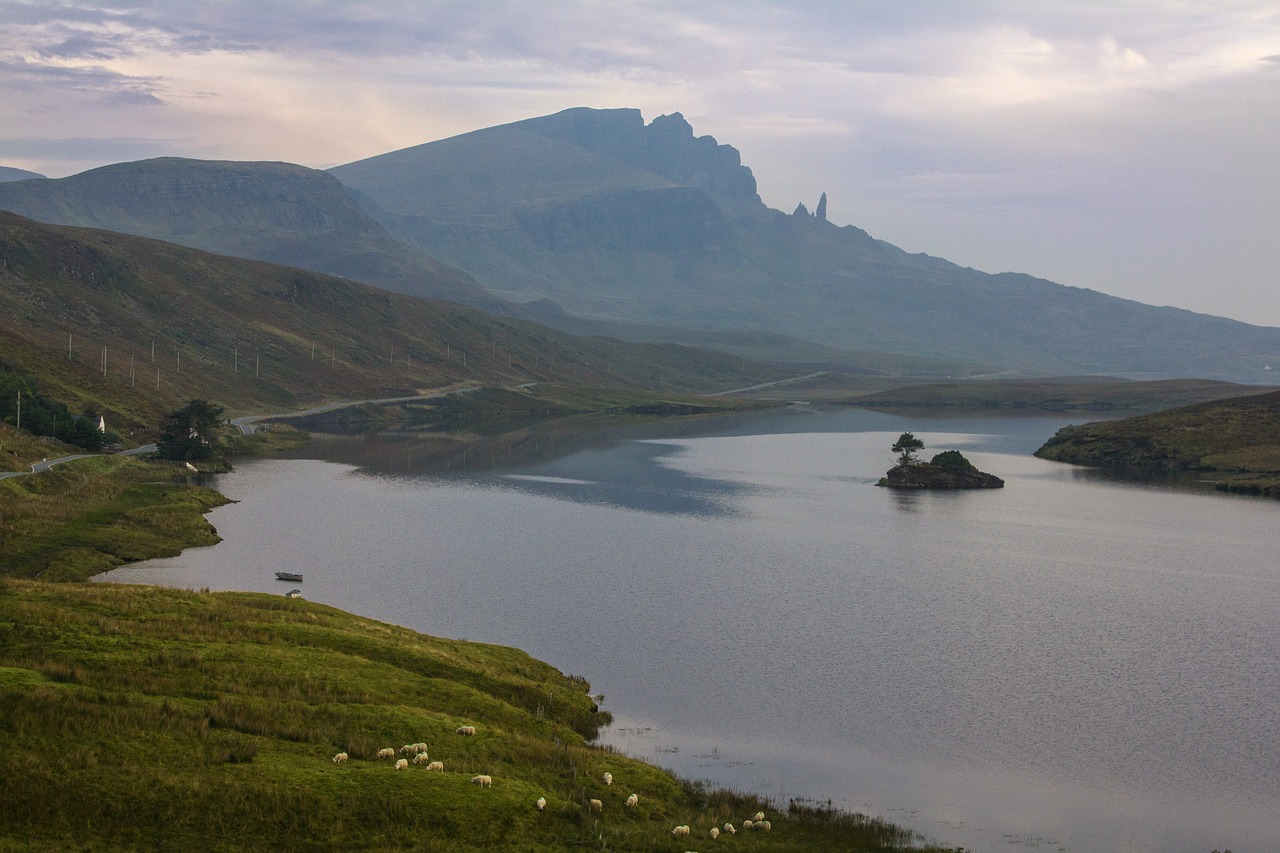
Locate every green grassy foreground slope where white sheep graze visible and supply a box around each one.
[0,579,942,852]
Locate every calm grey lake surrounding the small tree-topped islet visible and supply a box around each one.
[105,406,1280,853]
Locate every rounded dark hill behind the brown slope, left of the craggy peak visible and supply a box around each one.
[0,158,504,311]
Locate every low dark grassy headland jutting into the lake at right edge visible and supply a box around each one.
[1036,392,1280,497]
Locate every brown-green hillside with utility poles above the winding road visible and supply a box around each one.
[0,213,787,430]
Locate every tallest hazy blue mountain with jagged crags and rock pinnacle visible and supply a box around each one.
[330,109,1280,380]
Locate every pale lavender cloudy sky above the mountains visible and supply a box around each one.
[0,0,1280,327]
